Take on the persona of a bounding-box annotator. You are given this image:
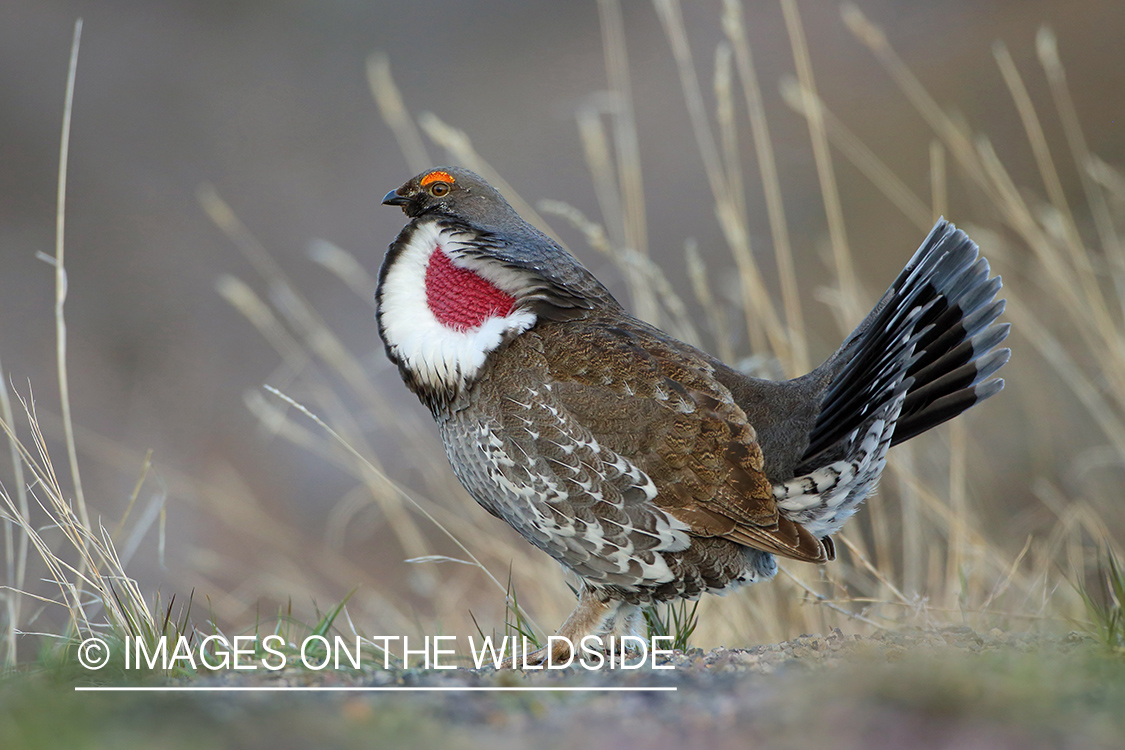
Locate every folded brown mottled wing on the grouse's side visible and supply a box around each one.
[538,318,829,562]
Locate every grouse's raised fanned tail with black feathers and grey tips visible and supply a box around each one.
[774,219,1011,535]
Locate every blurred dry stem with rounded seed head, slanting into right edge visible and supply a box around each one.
[1035,26,1125,305]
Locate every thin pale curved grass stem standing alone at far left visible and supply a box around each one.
[54,18,90,527]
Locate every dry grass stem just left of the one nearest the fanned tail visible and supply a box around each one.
[722,0,811,374]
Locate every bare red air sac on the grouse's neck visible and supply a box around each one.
[425,247,515,331]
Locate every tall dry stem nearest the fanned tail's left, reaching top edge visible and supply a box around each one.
[781,0,866,319]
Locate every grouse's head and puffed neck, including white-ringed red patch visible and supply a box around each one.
[376,166,621,415]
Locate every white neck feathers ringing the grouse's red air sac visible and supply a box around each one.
[381,223,536,387]
